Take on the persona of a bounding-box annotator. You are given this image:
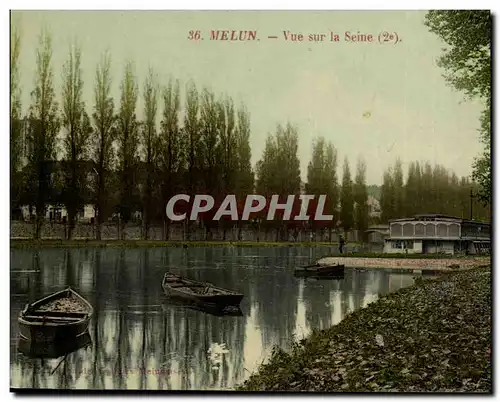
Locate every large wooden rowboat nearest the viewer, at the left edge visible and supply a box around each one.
[18,288,94,343]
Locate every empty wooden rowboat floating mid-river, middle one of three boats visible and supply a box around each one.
[162,272,243,308]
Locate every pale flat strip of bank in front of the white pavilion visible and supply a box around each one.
[318,254,491,271]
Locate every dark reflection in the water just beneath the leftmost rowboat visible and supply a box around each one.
[17,332,92,359]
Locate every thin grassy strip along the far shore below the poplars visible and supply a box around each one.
[10,239,344,248]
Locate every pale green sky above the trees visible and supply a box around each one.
[12,11,481,184]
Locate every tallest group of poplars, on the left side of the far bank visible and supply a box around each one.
[11,29,254,239]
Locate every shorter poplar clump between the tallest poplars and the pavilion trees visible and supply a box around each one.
[256,133,369,242]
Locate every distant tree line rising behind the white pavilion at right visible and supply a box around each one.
[380,160,491,222]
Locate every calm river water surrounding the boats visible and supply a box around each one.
[10,247,413,390]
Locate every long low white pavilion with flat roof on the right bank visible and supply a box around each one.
[384,214,491,254]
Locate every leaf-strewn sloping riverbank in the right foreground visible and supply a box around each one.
[237,267,492,393]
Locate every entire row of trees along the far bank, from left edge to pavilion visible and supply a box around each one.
[10,27,490,239]
